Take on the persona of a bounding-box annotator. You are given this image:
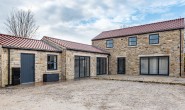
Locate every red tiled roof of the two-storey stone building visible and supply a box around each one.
[92,18,184,40]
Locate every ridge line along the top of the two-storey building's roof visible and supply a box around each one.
[101,18,184,33]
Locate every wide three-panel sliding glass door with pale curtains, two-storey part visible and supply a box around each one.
[140,56,169,75]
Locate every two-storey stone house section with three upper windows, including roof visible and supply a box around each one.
[92,18,185,77]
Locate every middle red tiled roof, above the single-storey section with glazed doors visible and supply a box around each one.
[42,36,109,54]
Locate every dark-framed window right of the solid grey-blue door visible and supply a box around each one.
[47,55,57,70]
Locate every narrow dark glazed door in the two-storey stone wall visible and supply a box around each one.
[117,57,125,74]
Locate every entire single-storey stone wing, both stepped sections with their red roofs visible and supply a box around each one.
[0,34,109,87]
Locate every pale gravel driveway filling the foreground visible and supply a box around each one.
[0,79,185,110]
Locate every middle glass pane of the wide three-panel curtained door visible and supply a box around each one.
[149,57,158,74]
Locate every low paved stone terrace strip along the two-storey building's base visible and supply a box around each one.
[92,75,185,86]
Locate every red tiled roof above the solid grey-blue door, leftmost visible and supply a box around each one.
[0,34,60,52]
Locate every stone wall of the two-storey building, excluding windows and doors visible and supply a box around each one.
[92,30,184,77]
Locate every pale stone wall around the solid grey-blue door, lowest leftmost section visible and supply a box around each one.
[1,49,64,87]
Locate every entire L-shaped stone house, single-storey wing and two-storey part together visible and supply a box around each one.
[0,18,185,87]
